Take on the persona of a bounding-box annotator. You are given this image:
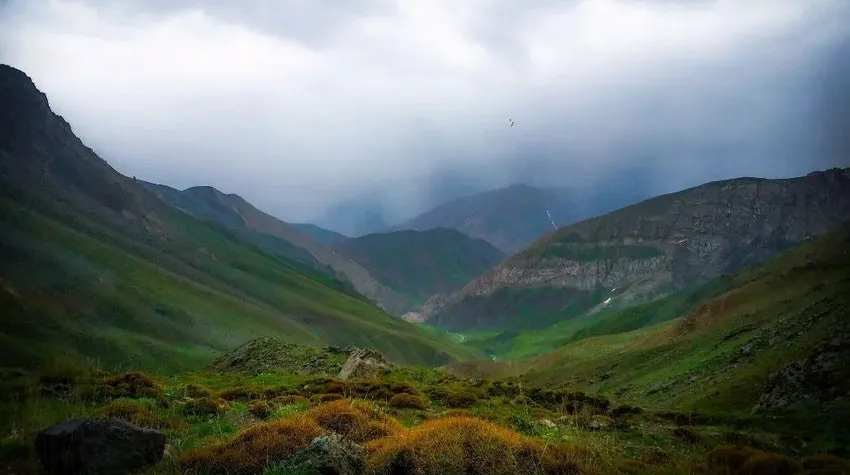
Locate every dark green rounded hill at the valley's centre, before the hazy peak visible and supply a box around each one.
[337,228,505,307]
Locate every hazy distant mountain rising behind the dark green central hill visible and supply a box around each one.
[391,184,646,253]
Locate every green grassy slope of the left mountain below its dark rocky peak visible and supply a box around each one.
[0,193,474,371]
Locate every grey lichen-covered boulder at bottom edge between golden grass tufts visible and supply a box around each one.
[284,434,366,475]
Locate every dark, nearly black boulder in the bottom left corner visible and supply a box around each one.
[35,419,165,475]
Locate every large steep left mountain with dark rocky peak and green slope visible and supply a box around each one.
[0,65,475,371]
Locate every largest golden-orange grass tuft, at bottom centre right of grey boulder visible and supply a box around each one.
[366,417,583,475]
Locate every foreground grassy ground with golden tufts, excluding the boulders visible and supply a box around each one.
[0,369,847,475]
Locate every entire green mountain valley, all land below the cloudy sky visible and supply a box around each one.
[0,60,850,475]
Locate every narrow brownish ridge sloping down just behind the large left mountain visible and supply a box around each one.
[142,182,409,314]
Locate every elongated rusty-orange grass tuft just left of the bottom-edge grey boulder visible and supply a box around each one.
[180,418,324,475]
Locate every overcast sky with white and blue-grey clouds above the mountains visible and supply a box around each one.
[0,0,850,225]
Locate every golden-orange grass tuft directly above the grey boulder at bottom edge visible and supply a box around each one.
[306,399,402,443]
